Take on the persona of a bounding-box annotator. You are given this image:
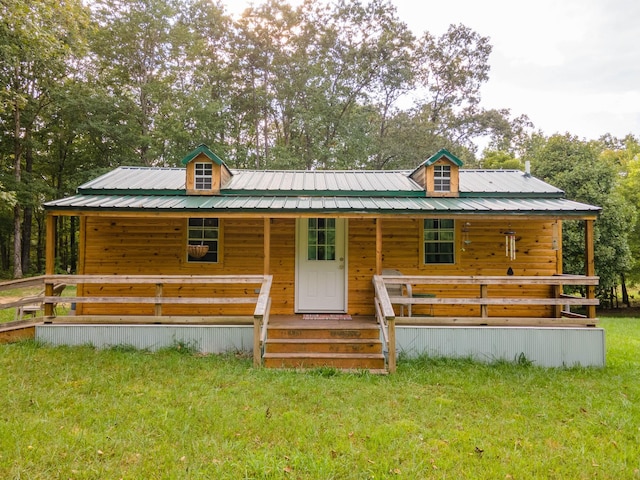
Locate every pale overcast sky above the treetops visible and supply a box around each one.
[223,0,640,140]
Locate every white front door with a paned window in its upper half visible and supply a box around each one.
[296,218,347,313]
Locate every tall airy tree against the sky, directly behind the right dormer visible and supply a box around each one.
[376,25,531,168]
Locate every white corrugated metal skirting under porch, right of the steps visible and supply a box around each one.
[396,326,605,367]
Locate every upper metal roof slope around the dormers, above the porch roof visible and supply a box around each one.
[78,167,563,197]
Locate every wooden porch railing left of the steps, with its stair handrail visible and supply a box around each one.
[3,275,273,366]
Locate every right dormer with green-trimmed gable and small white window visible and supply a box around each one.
[410,148,462,197]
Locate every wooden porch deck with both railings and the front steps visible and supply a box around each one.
[0,275,598,373]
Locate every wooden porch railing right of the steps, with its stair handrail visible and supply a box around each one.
[373,275,599,371]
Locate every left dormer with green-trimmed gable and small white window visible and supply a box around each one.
[182,145,232,195]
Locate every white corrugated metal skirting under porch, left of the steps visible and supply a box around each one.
[36,325,253,353]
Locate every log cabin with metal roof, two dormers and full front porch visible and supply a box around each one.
[41,145,604,371]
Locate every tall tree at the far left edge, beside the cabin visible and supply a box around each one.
[0,0,87,278]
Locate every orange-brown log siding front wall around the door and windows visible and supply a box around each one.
[78,216,561,316]
